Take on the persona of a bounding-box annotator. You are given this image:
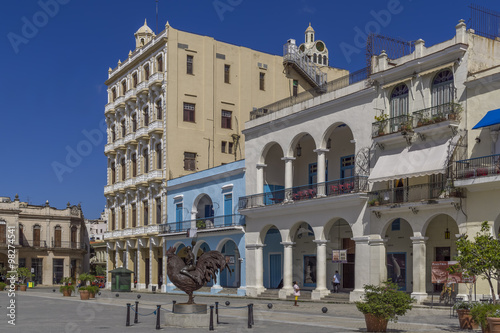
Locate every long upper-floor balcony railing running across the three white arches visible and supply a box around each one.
[239,176,368,209]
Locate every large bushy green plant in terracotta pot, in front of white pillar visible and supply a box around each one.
[356,281,415,332]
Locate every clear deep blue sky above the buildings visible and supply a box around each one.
[0,0,500,218]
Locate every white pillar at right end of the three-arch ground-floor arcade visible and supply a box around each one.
[349,236,370,302]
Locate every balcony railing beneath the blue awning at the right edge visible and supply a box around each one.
[454,154,500,179]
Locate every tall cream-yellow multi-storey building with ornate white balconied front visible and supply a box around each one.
[104,22,346,289]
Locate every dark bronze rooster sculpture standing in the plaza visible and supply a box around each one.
[167,247,228,304]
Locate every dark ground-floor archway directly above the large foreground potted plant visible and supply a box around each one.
[384,218,413,292]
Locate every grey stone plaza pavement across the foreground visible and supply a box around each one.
[0,287,466,333]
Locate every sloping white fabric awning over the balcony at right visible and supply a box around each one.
[368,135,460,182]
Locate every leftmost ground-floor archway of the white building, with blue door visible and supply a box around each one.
[263,226,283,289]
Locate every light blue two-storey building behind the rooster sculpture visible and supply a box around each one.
[161,160,246,296]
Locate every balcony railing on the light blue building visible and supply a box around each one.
[159,214,245,233]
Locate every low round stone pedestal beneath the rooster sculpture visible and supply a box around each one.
[164,303,217,329]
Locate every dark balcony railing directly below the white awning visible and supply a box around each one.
[368,181,464,206]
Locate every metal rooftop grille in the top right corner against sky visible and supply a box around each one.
[469,4,500,39]
